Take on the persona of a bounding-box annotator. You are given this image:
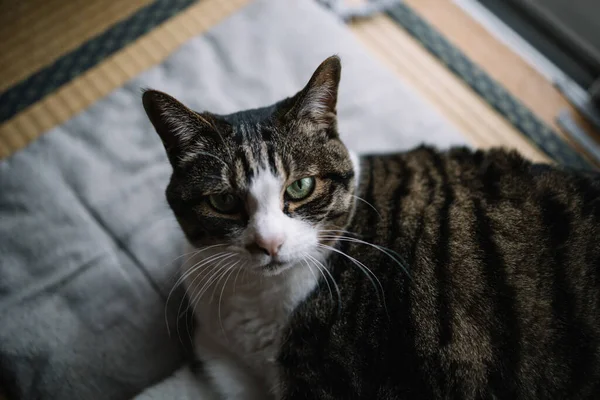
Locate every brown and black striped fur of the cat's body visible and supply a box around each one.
[280,147,600,400]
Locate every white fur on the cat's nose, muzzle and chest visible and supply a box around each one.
[185,170,324,400]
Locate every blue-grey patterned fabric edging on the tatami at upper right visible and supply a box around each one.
[387,4,593,169]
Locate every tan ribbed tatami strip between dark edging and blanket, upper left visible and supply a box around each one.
[0,0,250,159]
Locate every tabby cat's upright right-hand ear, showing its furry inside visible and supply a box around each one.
[288,56,342,126]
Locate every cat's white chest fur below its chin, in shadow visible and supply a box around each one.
[186,255,317,399]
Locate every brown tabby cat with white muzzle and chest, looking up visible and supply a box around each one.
[143,56,600,400]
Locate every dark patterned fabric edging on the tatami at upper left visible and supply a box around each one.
[0,0,197,123]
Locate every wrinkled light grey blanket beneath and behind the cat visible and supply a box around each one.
[0,0,464,400]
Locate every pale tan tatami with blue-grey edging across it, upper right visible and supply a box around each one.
[354,0,599,169]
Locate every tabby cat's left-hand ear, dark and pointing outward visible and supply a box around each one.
[142,90,214,158]
